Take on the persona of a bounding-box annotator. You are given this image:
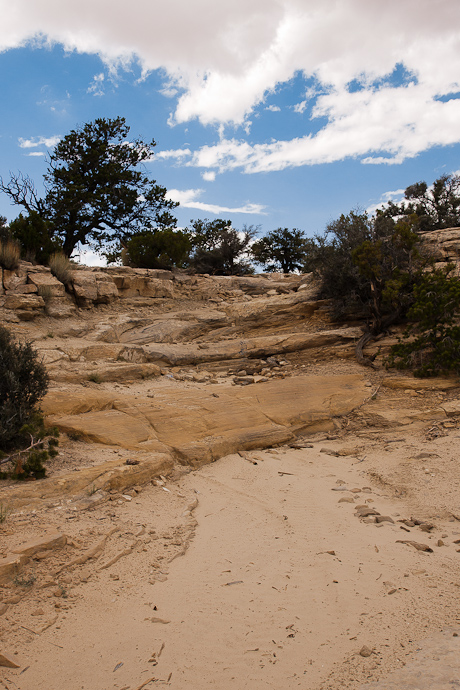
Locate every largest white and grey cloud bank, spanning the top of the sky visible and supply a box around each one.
[0,0,460,167]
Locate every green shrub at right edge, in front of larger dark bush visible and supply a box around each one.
[388,266,460,377]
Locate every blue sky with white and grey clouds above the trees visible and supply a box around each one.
[0,0,460,264]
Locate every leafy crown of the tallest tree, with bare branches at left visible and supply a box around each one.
[0,117,177,256]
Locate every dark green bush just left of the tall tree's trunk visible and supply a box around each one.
[10,211,60,265]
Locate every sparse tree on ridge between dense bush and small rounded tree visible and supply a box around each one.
[188,218,257,275]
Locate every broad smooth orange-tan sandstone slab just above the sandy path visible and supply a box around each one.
[44,376,365,465]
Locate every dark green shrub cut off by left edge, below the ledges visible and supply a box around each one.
[0,326,57,478]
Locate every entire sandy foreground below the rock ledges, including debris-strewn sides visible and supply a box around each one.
[0,425,460,690]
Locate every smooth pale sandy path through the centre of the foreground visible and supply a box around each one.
[10,442,459,690]
